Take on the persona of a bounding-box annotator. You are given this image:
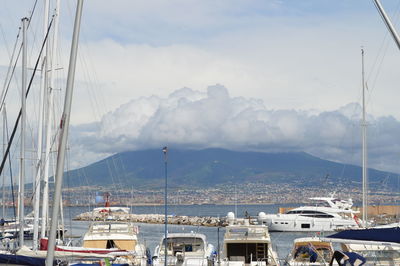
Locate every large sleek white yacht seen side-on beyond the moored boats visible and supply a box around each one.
[259,197,359,232]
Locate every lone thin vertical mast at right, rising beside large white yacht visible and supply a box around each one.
[361,49,368,227]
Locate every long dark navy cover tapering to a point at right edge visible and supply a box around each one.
[328,227,400,244]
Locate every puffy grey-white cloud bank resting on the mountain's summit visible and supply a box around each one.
[71,85,400,172]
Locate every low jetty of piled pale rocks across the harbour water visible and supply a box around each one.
[74,212,227,227]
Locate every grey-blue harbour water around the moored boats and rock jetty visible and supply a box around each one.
[59,204,315,259]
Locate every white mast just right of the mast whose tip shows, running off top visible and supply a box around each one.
[32,0,49,250]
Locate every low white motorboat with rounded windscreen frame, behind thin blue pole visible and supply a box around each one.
[153,232,214,266]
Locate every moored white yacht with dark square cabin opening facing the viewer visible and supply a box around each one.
[220,212,279,266]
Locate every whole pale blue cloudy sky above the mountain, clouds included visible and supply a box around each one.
[0,0,400,173]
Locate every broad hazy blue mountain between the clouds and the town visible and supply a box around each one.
[64,149,397,189]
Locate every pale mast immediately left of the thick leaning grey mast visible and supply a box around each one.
[40,0,60,238]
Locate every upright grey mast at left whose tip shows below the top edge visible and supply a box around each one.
[18,18,29,247]
